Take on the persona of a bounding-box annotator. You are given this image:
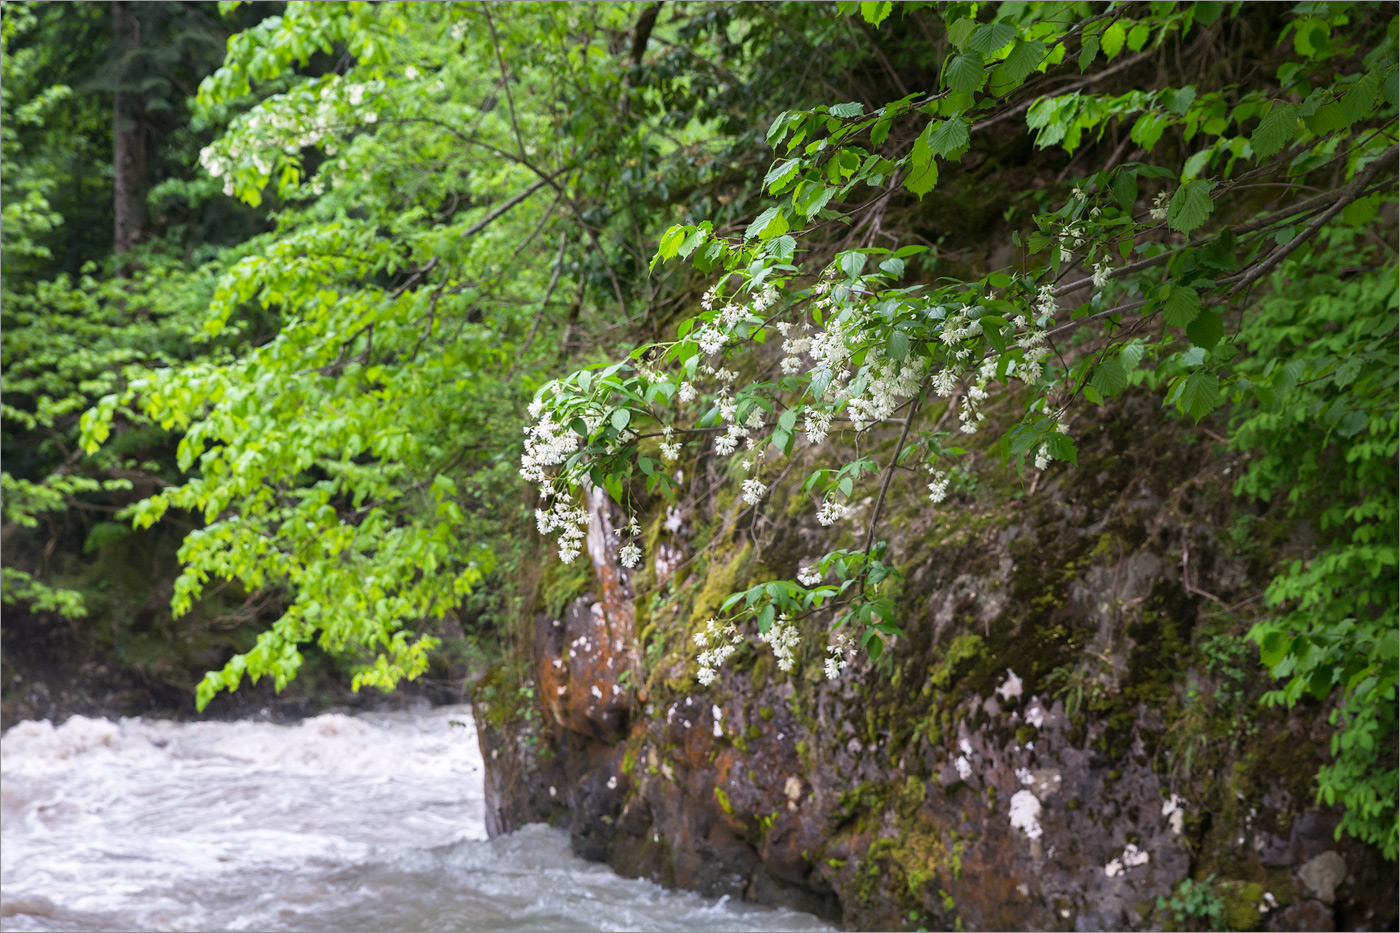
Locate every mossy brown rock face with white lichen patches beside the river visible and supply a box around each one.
[476,396,1396,930]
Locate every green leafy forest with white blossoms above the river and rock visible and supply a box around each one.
[0,3,1397,874]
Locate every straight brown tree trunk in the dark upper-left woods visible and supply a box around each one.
[112,0,146,254]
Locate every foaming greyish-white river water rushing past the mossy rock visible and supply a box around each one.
[0,706,830,930]
